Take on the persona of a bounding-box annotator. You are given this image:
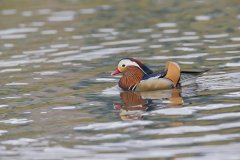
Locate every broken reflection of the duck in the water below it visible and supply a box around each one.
[114,89,183,120]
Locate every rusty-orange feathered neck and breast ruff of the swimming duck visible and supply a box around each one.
[118,66,144,90]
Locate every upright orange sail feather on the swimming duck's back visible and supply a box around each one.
[164,61,181,87]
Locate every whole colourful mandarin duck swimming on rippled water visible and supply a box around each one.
[111,58,205,91]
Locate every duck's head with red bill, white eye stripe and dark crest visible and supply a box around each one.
[111,58,153,76]
